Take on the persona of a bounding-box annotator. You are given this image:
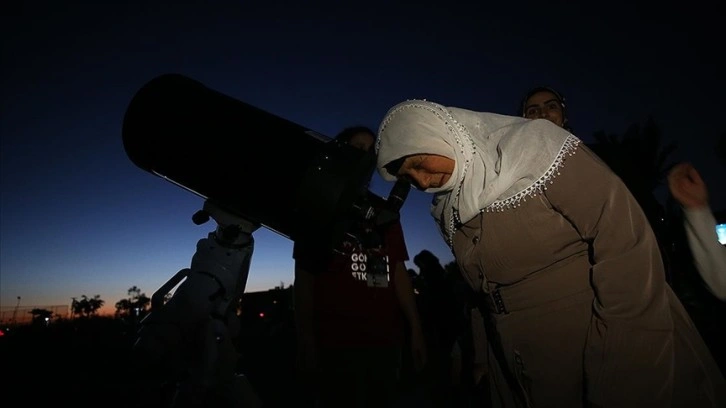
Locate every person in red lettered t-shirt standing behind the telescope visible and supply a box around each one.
[293,126,426,408]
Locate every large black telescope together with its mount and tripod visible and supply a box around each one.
[122,74,410,408]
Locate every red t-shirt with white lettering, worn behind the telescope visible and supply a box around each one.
[293,222,408,347]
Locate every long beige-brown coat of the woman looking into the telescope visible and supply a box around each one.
[453,145,726,408]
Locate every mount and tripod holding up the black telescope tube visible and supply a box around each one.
[134,200,262,408]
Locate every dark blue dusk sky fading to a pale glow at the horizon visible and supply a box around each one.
[0,1,726,307]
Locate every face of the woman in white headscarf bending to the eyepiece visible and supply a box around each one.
[396,154,455,190]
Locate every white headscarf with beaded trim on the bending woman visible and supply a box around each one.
[376,100,580,246]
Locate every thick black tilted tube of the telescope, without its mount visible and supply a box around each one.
[122,74,374,245]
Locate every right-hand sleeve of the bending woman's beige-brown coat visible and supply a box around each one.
[545,144,674,407]
